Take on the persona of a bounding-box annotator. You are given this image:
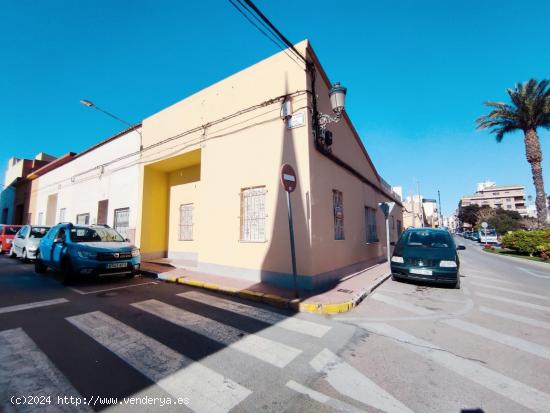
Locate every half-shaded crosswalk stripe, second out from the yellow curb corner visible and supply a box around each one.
[132,300,302,368]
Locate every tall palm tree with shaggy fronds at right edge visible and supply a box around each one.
[476,79,550,227]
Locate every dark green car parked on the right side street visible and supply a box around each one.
[391,228,465,288]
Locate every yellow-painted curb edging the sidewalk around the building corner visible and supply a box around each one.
[150,271,391,314]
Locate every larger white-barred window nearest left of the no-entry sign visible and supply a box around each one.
[241,186,267,242]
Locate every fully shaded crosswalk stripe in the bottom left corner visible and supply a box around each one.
[0,328,91,412]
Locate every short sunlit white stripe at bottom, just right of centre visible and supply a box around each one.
[309,348,412,413]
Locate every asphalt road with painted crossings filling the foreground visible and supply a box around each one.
[0,241,550,413]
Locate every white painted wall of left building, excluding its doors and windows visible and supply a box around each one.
[29,131,141,236]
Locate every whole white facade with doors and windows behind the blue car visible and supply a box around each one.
[29,127,141,241]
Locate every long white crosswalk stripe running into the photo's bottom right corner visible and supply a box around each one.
[361,323,550,413]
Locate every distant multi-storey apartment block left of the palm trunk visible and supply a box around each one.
[460,181,528,216]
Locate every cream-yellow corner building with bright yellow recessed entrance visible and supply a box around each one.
[136,41,402,289]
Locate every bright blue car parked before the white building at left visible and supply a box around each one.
[35,223,140,284]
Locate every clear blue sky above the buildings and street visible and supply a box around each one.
[0,0,550,214]
